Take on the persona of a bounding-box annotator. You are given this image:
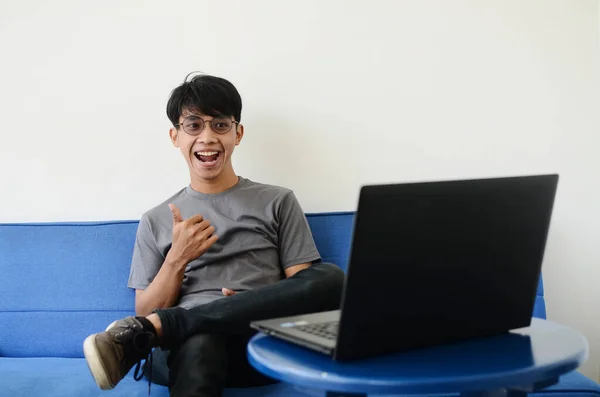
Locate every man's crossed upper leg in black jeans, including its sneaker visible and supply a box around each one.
[83,263,344,389]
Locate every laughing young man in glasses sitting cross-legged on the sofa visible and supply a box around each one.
[83,75,344,397]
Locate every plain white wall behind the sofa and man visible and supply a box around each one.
[0,0,600,379]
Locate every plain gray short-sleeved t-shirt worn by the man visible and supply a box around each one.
[128,177,320,309]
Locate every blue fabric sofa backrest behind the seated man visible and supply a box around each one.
[0,212,546,357]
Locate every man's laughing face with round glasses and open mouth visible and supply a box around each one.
[170,110,244,181]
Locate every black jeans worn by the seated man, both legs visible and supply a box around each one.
[152,262,344,397]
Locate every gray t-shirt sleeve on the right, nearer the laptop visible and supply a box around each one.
[278,191,321,269]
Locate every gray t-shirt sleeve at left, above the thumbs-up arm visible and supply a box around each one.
[127,216,165,290]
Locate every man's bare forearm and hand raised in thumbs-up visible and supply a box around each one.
[135,204,217,316]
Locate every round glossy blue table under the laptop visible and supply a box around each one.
[248,318,588,397]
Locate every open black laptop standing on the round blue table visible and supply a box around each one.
[251,174,558,361]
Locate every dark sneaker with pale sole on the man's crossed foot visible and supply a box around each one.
[83,316,156,390]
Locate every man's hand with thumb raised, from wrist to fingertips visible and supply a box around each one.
[167,204,218,265]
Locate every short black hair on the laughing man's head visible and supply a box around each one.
[167,73,242,125]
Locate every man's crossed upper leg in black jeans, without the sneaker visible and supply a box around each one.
[149,263,344,346]
